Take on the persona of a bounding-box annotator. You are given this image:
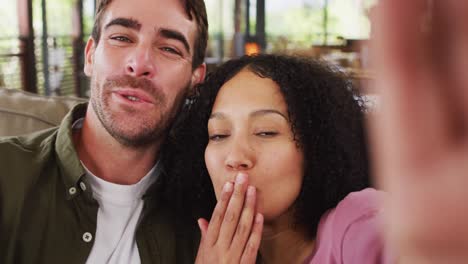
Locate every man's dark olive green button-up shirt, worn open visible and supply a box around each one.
[0,104,199,264]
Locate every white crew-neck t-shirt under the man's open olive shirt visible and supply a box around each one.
[83,164,159,264]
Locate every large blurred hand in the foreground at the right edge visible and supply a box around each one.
[369,0,468,263]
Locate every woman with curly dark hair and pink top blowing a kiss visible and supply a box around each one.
[165,55,384,263]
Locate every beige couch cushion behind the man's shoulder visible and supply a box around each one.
[0,88,87,136]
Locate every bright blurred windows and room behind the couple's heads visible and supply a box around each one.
[0,0,376,97]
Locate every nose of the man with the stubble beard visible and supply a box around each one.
[125,44,156,78]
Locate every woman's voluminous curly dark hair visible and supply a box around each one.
[165,55,369,238]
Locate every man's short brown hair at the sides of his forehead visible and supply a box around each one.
[91,0,208,69]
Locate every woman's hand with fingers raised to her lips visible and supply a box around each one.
[195,173,263,264]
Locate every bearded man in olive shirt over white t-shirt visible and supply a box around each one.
[0,0,208,263]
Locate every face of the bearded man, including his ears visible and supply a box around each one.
[85,0,205,147]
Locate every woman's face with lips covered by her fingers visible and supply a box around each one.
[205,69,304,221]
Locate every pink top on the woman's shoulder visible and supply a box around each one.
[306,188,391,264]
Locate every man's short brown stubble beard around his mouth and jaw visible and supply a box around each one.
[90,76,190,149]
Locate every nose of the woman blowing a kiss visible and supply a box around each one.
[225,142,255,171]
